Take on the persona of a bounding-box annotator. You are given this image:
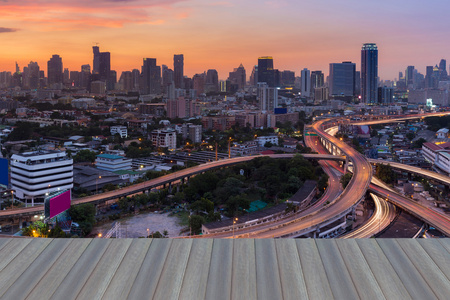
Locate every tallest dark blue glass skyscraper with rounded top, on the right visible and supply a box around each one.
[361,43,378,104]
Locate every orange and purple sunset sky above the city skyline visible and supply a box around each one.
[0,0,450,79]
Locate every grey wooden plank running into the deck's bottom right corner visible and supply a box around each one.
[397,239,450,299]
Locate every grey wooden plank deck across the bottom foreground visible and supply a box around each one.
[0,239,450,300]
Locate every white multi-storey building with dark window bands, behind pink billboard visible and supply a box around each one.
[11,150,73,205]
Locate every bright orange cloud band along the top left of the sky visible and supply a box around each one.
[0,0,187,31]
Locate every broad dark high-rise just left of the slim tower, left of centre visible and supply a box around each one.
[139,58,161,95]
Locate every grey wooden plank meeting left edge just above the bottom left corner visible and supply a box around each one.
[0,239,52,292]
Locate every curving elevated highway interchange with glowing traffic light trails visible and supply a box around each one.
[0,113,450,238]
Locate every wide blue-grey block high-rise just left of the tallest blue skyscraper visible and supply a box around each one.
[329,62,356,97]
